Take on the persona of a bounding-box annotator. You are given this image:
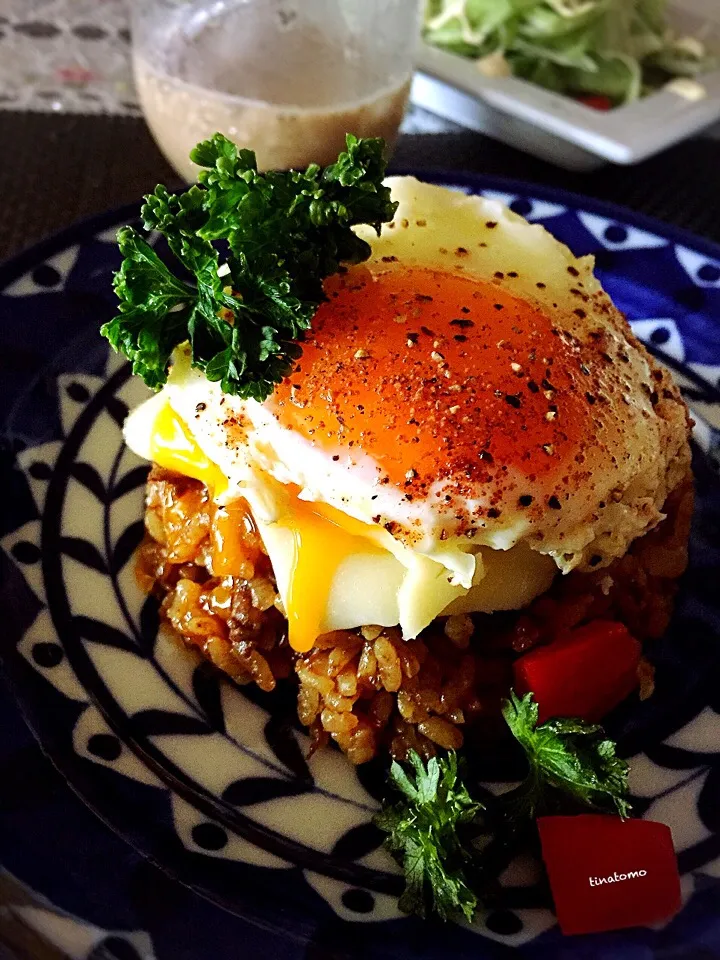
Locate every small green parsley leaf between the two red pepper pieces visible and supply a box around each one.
[503,691,630,817]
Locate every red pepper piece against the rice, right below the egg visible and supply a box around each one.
[513,620,642,723]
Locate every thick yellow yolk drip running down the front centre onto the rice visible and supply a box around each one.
[279,500,384,653]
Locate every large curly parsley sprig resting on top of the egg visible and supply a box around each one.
[101,134,397,400]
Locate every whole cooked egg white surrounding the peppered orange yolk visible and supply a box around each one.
[125,178,688,638]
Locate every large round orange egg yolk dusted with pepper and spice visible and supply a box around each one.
[266,264,606,496]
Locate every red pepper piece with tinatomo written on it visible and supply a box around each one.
[538,814,681,933]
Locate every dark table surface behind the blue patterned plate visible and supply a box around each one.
[0,112,720,259]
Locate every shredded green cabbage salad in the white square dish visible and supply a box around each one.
[424,0,716,107]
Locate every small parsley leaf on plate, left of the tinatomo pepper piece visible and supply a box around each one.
[375,751,482,920]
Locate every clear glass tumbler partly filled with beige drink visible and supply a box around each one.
[132,0,421,180]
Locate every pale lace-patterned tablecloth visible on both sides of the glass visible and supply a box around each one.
[0,0,452,133]
